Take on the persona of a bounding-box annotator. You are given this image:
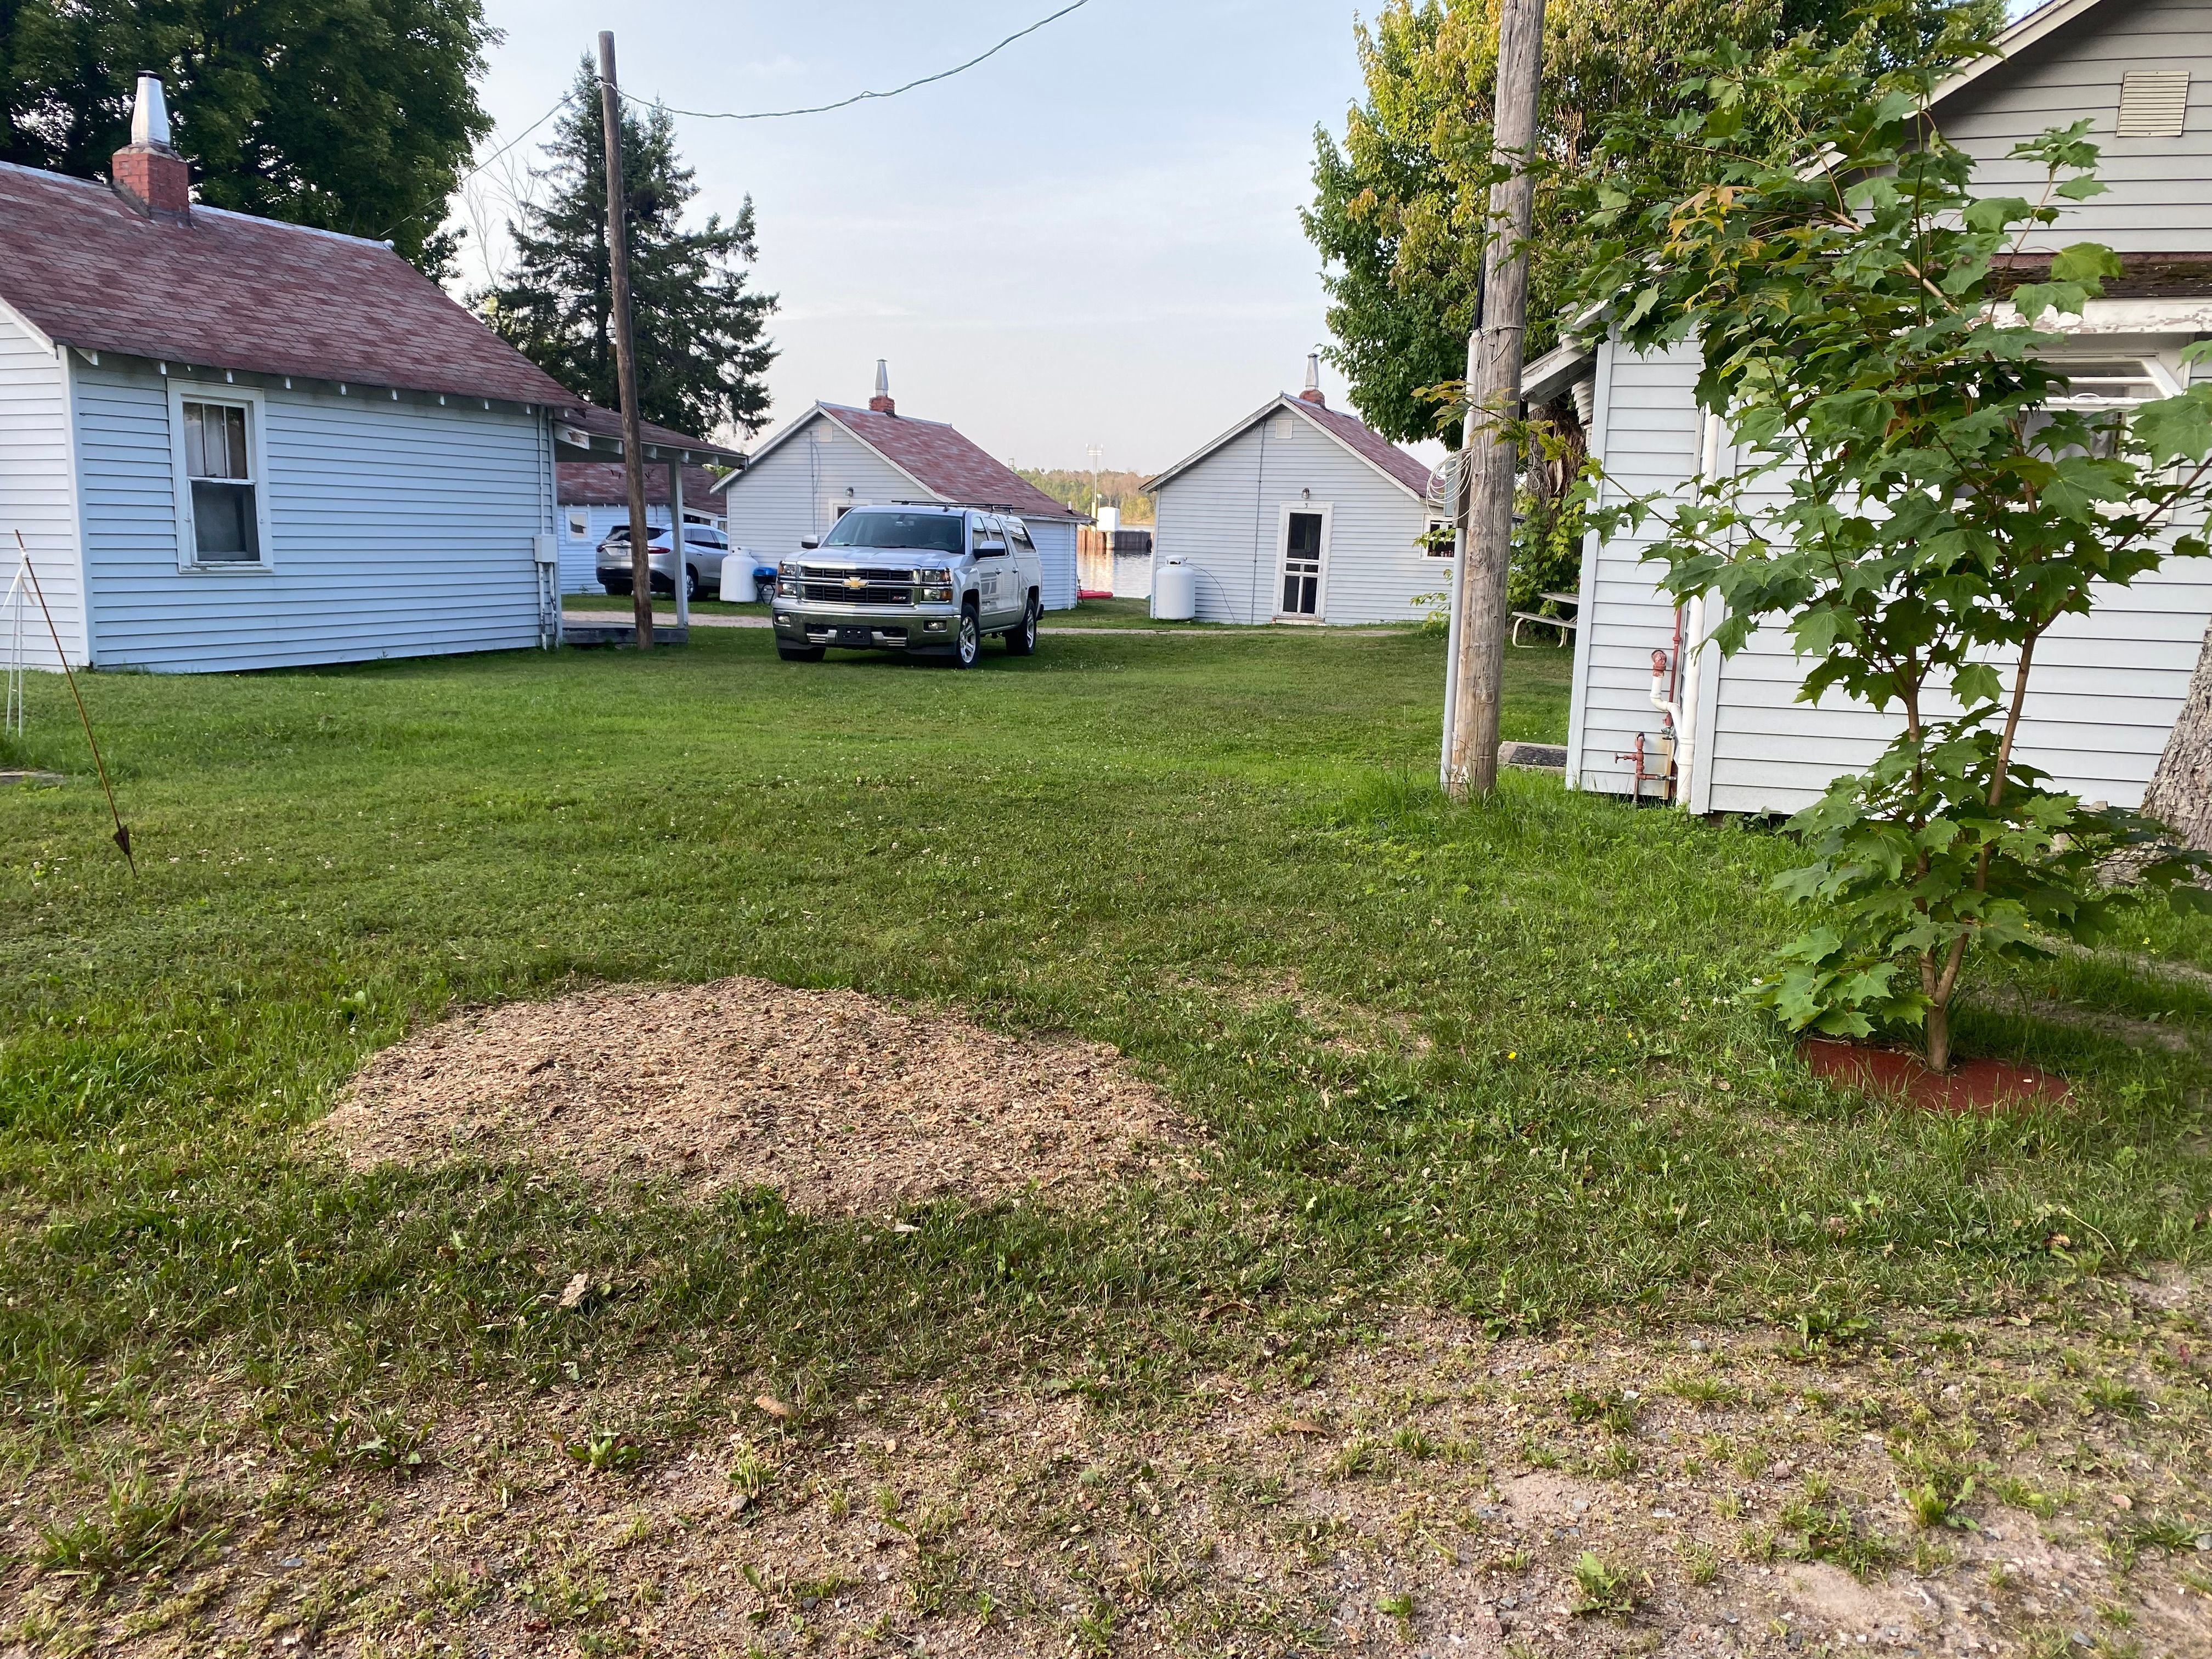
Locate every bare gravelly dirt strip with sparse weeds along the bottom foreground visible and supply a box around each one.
[0,1278,2212,1659]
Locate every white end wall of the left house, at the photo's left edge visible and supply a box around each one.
[0,305,91,670]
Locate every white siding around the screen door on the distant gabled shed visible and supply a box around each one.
[1153,407,1451,624]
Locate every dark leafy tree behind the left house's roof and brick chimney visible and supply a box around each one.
[0,0,498,276]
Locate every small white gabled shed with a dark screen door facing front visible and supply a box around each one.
[1144,365,1451,624]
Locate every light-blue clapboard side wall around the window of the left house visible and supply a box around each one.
[75,360,553,673]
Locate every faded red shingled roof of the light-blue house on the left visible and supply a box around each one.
[0,163,582,409]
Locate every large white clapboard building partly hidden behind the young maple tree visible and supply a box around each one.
[1557,0,2212,814]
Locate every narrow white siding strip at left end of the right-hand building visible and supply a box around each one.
[1566,343,1699,794]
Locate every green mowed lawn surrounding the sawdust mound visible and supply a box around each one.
[0,630,2212,1466]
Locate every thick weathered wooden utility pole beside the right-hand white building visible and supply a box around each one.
[1444,0,1544,801]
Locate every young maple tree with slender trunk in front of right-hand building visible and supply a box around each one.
[1584,9,2212,1070]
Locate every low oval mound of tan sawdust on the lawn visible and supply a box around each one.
[319,980,1186,1215]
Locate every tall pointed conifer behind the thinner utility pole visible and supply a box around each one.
[489,60,776,436]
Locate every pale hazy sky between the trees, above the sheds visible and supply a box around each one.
[462,0,1358,471]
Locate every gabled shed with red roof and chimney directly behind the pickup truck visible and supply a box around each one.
[716,363,1091,611]
